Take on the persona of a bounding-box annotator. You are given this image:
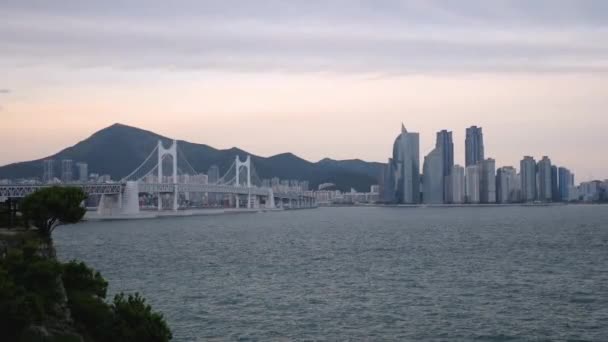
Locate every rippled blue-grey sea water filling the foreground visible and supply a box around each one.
[54,206,608,341]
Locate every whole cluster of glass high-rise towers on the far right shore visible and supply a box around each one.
[380,125,574,204]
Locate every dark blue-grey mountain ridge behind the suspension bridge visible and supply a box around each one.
[0,124,383,191]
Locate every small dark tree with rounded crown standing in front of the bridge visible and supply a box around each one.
[21,187,86,237]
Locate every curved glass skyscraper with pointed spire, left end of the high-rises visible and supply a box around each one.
[382,125,420,204]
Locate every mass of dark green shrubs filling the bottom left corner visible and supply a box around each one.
[0,232,172,342]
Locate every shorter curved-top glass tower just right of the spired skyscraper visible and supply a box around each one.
[422,147,445,204]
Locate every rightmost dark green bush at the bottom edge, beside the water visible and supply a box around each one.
[112,293,172,342]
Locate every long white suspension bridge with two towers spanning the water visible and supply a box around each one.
[0,141,316,216]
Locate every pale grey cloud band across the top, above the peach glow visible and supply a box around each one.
[0,1,608,74]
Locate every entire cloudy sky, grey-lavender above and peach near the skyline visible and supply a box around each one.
[0,0,608,180]
